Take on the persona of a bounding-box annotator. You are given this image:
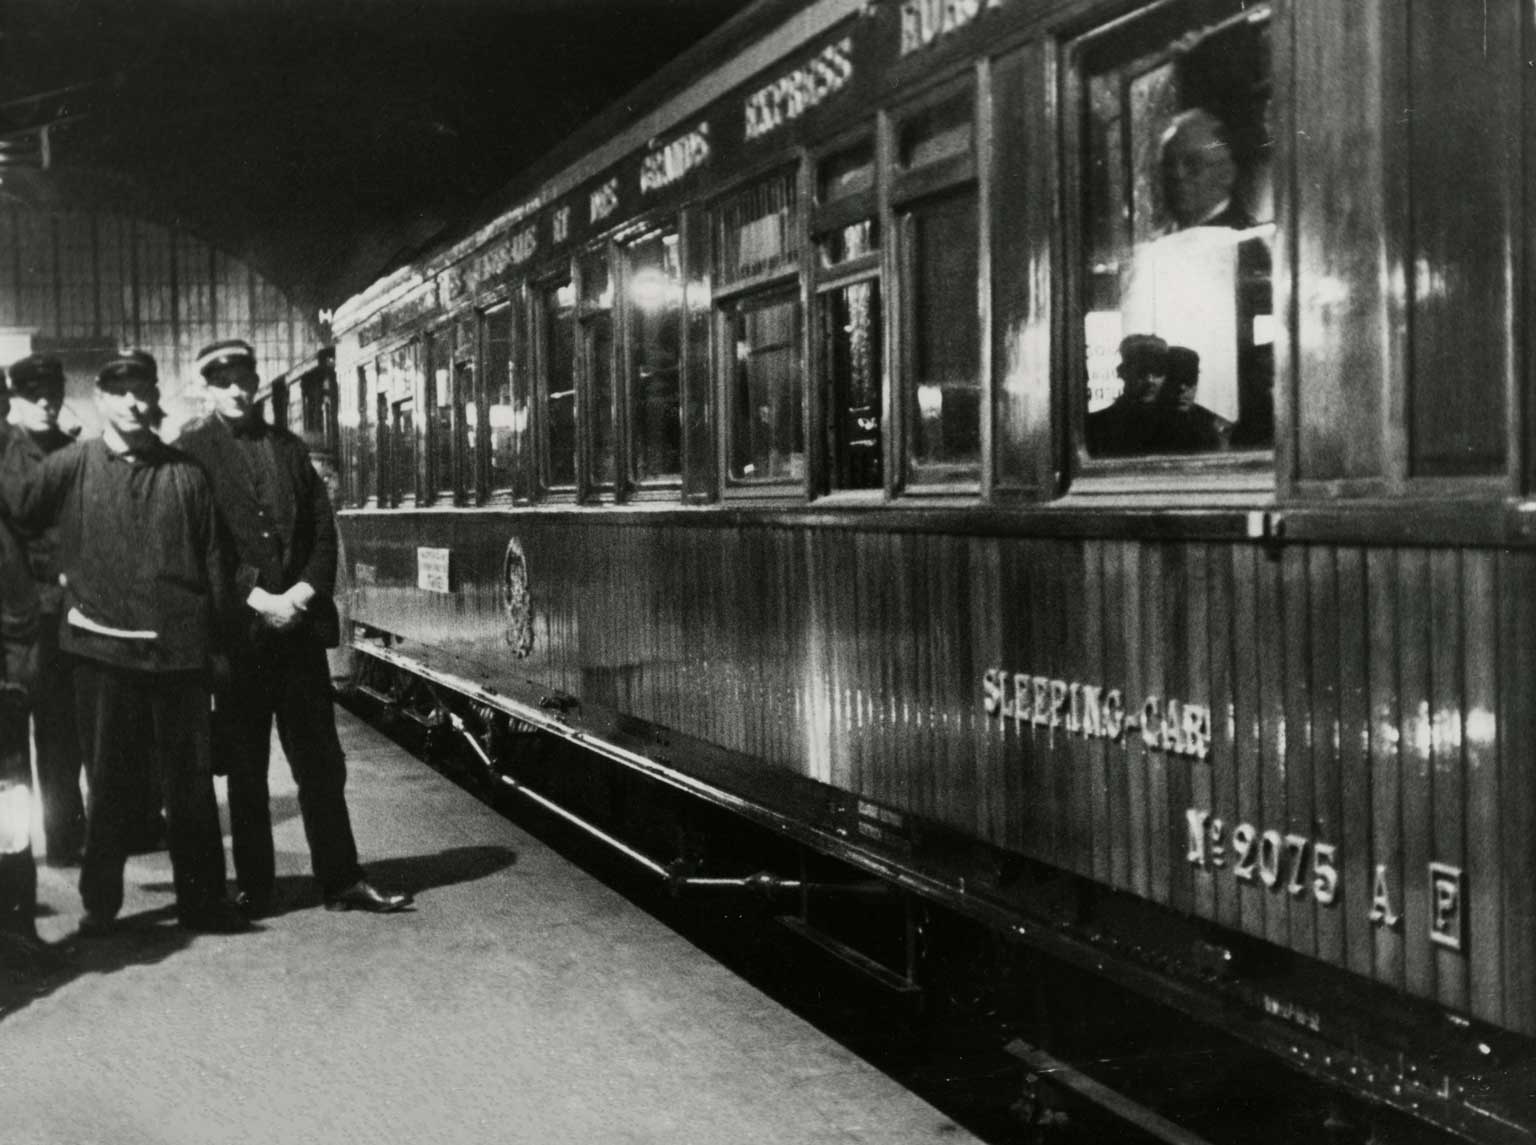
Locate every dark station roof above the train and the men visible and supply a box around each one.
[0,0,750,307]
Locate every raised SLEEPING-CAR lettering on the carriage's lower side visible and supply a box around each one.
[982,669,1210,759]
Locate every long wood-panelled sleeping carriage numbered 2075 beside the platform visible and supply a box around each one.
[324,0,1536,1140]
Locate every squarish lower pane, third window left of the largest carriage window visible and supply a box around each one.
[727,298,805,481]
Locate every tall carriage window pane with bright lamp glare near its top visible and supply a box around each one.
[628,231,682,481]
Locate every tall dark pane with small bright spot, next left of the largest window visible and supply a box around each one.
[905,192,982,484]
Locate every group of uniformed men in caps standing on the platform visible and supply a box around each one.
[0,341,410,942]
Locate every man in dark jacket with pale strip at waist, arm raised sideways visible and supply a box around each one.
[0,350,247,934]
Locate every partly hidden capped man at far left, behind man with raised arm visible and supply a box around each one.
[9,353,85,867]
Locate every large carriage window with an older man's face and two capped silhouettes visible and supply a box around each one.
[1080,0,1275,458]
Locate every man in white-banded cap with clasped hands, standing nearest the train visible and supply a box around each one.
[177,341,410,918]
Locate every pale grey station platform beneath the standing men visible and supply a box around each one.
[0,710,975,1145]
